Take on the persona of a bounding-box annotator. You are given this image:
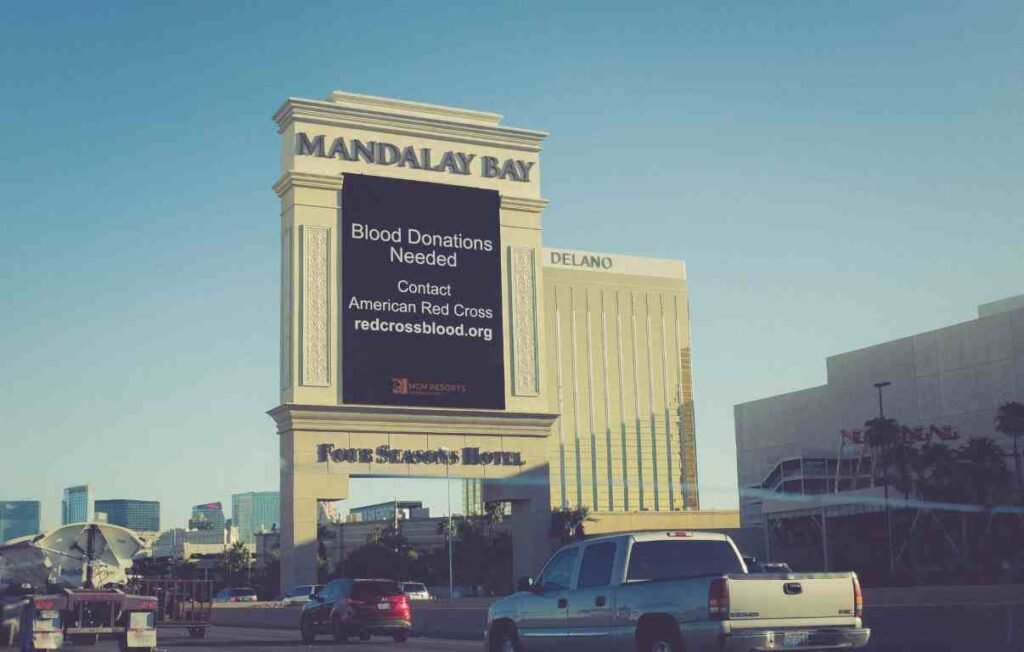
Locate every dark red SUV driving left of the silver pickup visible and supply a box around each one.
[299,579,413,643]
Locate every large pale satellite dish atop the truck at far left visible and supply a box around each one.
[0,523,145,589]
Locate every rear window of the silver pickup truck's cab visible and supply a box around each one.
[626,540,743,581]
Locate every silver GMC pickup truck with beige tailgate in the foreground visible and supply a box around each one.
[483,531,870,652]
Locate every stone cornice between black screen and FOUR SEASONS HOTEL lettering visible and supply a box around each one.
[267,403,558,437]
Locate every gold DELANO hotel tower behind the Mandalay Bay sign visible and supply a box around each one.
[464,248,699,515]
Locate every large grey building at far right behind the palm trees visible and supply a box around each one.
[735,296,1024,527]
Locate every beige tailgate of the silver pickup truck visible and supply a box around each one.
[728,573,854,620]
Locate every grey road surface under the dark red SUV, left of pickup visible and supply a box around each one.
[76,626,482,652]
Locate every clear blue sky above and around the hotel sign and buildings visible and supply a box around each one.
[0,0,1024,527]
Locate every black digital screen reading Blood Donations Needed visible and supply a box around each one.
[340,174,505,409]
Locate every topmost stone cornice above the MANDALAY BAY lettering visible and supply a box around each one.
[273,97,548,153]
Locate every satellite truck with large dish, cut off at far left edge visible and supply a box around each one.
[0,523,158,652]
